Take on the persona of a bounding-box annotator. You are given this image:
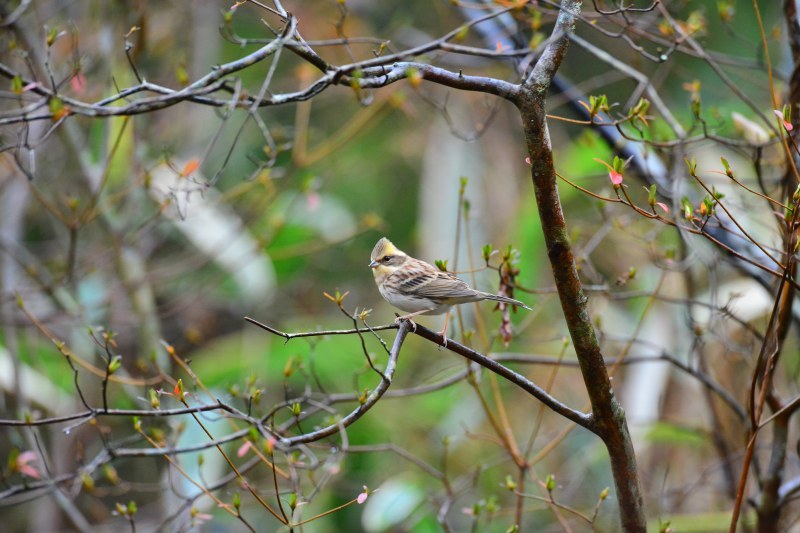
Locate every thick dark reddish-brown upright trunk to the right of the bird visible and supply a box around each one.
[515,0,646,532]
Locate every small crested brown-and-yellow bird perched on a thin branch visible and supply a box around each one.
[369,237,530,337]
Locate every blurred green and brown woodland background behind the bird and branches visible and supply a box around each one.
[0,0,797,531]
